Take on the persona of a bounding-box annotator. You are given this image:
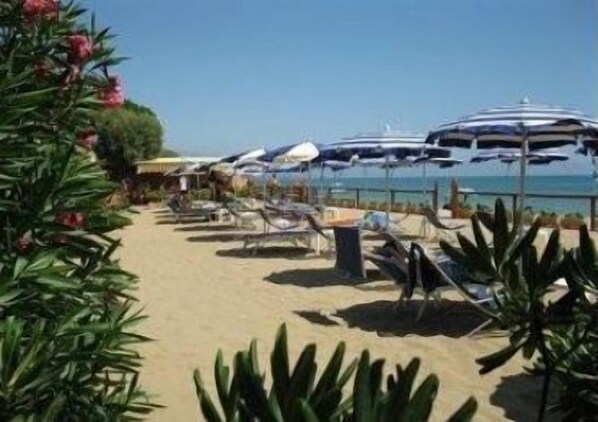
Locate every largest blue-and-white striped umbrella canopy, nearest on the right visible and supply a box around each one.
[426,99,598,150]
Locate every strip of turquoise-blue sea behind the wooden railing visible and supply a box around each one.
[311,175,598,216]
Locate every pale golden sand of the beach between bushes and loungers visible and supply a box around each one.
[120,209,580,421]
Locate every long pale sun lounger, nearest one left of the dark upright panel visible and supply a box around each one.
[243,209,313,255]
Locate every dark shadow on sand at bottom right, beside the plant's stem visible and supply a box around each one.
[490,373,561,422]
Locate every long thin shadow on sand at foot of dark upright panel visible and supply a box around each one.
[264,268,382,288]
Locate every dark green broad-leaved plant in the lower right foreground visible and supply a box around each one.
[441,200,598,421]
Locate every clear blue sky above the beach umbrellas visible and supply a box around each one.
[85,0,598,173]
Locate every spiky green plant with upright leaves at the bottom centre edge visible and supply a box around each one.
[194,325,477,422]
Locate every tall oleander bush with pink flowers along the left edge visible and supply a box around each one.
[0,0,154,421]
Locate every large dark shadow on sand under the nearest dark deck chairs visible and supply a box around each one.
[296,299,485,338]
